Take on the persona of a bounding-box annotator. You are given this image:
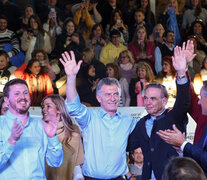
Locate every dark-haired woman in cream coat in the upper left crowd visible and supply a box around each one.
[21,15,52,64]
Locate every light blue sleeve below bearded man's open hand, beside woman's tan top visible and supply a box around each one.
[46,136,63,167]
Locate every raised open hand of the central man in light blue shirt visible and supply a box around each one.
[60,51,82,76]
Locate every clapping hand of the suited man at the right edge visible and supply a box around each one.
[157,125,185,148]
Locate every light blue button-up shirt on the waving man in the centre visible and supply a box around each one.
[66,96,138,179]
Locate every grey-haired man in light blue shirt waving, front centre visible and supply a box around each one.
[60,52,137,180]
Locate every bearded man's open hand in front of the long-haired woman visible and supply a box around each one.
[42,113,60,137]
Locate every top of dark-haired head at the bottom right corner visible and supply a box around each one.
[162,157,206,180]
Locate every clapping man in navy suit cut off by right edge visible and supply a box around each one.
[157,81,207,176]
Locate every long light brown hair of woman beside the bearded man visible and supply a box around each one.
[42,94,81,150]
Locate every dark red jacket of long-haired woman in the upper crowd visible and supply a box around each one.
[128,40,155,70]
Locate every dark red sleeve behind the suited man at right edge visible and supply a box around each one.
[188,85,207,144]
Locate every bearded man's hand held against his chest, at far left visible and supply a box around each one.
[9,119,23,145]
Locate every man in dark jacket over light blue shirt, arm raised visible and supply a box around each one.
[128,41,195,180]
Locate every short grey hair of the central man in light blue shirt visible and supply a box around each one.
[96,77,121,95]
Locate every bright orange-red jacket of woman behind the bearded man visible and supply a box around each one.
[14,64,54,106]
